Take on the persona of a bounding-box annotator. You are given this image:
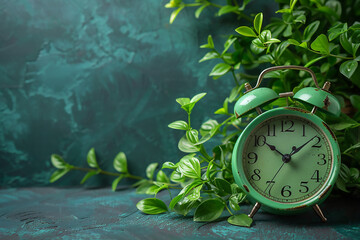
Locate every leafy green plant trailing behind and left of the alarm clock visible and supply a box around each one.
[51,0,360,226]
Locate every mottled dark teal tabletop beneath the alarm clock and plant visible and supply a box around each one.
[0,187,360,239]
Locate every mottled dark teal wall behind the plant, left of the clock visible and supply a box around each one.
[0,0,245,187]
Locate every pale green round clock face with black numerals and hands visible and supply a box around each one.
[239,115,333,203]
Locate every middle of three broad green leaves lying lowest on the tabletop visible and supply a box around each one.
[194,198,225,222]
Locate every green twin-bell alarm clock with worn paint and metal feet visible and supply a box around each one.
[232,66,341,222]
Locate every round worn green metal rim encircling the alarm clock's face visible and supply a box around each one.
[232,107,341,214]
